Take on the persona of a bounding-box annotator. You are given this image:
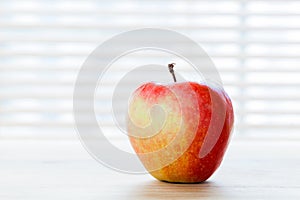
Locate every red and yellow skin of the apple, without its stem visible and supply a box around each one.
[127,82,234,183]
